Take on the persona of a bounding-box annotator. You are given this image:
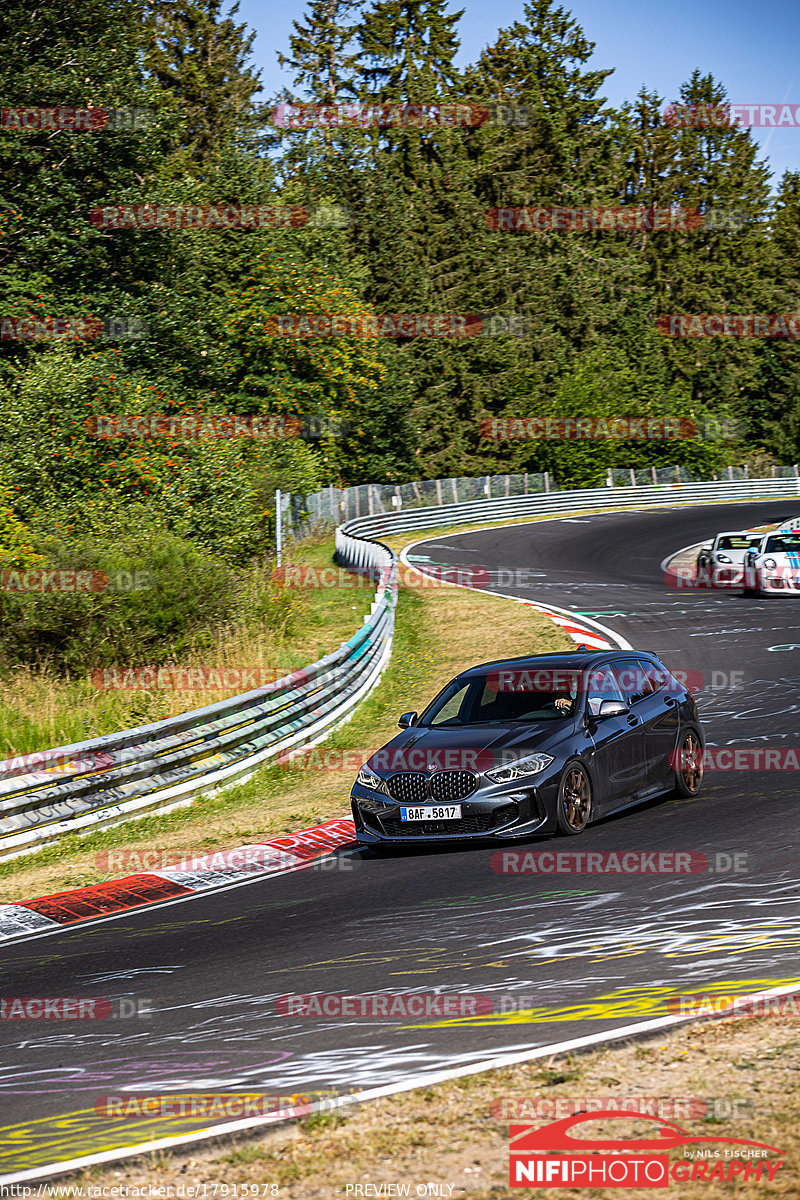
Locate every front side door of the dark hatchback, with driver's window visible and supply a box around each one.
[585,666,645,811]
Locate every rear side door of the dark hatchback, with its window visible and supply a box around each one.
[614,658,680,791]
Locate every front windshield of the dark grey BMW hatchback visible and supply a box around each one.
[419,667,581,728]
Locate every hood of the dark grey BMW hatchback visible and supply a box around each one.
[368,716,576,773]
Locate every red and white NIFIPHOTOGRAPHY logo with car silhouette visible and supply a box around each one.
[509,1109,786,1188]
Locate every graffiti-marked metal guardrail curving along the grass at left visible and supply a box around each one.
[0,532,397,858]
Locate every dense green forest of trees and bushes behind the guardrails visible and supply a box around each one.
[0,0,800,671]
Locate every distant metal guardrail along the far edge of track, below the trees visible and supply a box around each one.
[337,475,800,538]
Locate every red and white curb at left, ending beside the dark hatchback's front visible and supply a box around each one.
[0,817,355,941]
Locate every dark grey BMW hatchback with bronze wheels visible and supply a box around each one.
[350,648,704,846]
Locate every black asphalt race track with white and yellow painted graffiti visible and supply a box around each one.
[0,498,800,1177]
